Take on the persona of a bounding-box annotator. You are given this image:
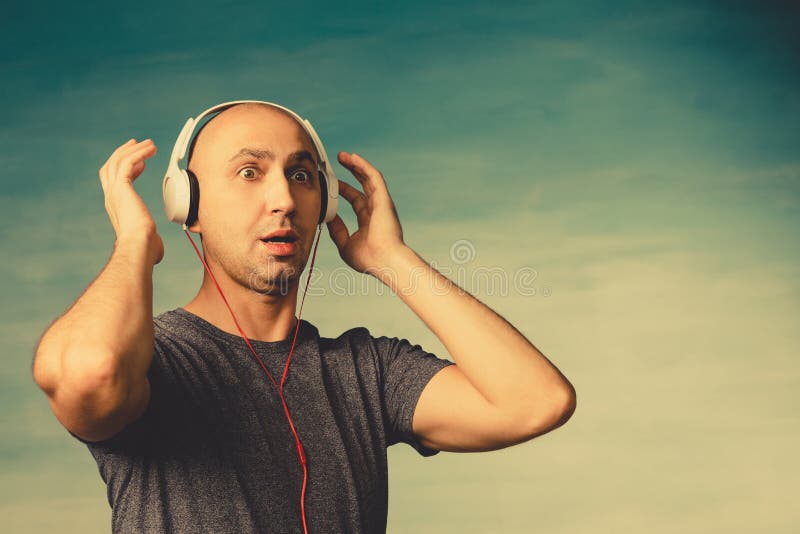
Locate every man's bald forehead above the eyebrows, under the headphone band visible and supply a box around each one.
[195,106,315,164]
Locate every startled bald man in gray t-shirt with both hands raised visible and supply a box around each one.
[34,104,575,532]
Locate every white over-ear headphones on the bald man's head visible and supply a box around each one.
[162,100,339,228]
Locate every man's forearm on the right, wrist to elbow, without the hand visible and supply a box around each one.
[376,247,574,422]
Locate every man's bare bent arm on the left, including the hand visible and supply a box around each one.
[33,139,164,441]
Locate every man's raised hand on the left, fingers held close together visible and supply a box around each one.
[99,139,164,265]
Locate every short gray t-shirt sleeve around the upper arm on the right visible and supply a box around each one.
[372,336,455,456]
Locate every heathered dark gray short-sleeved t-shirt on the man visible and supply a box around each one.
[73,308,453,534]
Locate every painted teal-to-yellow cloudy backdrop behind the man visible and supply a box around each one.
[0,0,800,534]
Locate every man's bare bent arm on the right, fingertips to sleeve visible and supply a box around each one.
[328,152,576,452]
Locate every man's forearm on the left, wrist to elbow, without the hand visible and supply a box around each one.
[34,236,154,402]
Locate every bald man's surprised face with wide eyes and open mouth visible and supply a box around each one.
[190,106,321,294]
